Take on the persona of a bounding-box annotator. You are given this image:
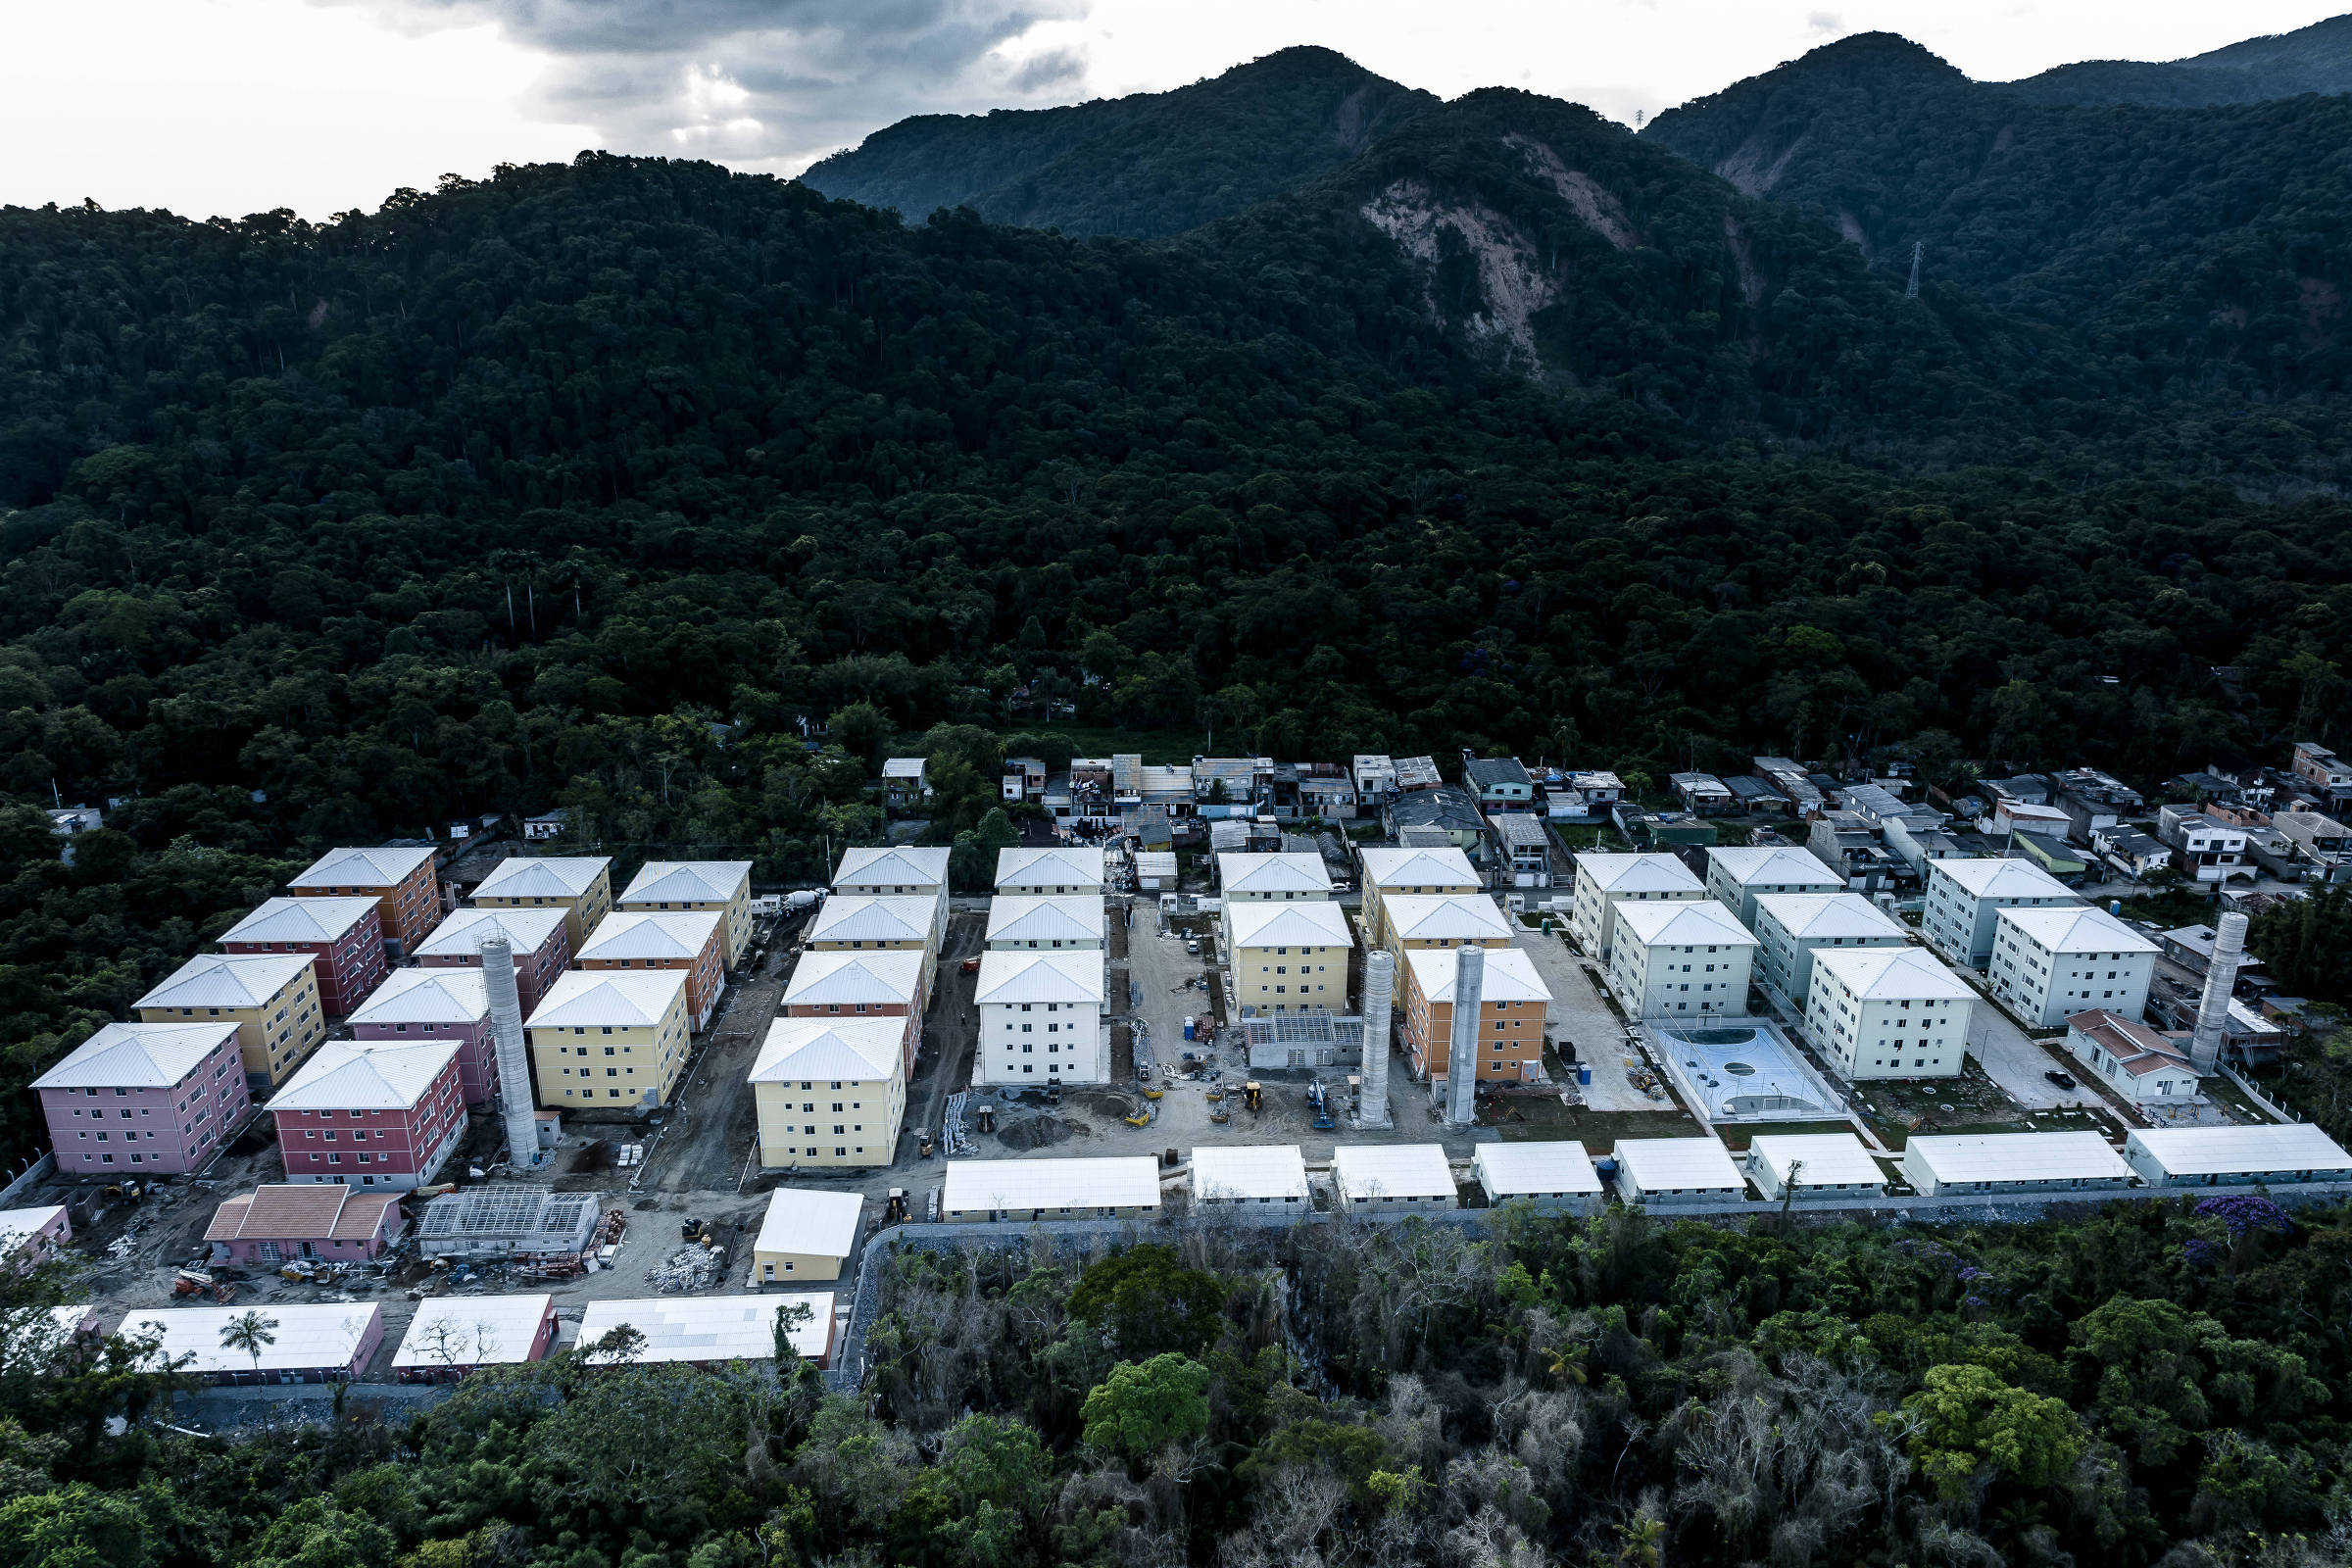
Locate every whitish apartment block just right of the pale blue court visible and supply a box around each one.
[1804,948,1976,1079]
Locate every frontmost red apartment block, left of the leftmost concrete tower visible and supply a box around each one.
[269,1039,466,1192]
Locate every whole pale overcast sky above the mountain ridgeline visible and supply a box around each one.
[0,0,2345,217]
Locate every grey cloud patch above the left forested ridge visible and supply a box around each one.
[345,0,1087,172]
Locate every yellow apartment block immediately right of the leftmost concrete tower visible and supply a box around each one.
[522,968,689,1114]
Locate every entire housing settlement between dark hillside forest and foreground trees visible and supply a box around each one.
[14,743,2352,1382]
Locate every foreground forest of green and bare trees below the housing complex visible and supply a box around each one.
[0,1199,2352,1568]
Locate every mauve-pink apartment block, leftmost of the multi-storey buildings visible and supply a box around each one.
[33,1018,254,1180]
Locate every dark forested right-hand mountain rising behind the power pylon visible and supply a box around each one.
[1644,35,2352,397]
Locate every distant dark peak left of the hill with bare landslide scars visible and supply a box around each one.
[802,47,1437,237]
